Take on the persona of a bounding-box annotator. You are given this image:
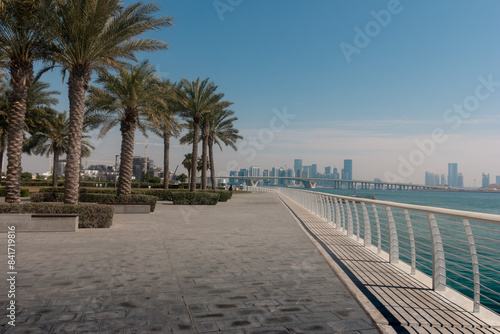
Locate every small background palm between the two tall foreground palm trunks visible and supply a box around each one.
[24,111,94,188]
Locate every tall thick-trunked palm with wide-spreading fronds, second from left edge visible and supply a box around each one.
[52,0,172,204]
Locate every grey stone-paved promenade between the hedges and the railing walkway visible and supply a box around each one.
[0,193,378,334]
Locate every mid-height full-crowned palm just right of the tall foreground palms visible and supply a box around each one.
[87,61,165,195]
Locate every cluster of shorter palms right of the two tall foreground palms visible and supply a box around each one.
[84,65,242,195]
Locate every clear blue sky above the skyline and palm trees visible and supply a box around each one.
[24,0,500,186]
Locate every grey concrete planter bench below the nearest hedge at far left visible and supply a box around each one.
[0,213,78,233]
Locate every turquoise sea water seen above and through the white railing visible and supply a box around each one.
[302,188,500,313]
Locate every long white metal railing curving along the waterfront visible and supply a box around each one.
[248,187,500,313]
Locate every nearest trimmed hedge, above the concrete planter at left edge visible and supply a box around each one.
[0,203,114,228]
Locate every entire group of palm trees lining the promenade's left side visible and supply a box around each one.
[0,0,241,204]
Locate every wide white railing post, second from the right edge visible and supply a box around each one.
[427,213,446,291]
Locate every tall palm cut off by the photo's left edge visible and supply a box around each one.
[0,0,57,203]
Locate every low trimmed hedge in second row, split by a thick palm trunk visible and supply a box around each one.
[30,192,156,212]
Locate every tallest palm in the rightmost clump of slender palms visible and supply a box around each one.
[179,78,224,191]
